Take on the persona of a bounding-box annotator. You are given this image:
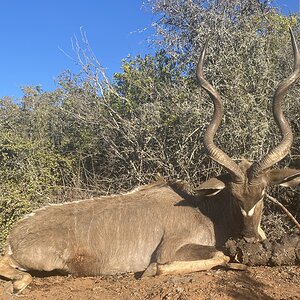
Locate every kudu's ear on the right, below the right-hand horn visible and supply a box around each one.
[268,168,300,187]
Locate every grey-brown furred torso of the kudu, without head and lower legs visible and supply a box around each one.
[4,178,233,275]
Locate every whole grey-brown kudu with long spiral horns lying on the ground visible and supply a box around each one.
[0,33,300,291]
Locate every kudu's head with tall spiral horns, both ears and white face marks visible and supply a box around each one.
[197,30,300,240]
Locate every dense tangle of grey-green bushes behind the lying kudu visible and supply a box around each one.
[0,0,300,250]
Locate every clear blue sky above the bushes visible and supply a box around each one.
[0,0,300,98]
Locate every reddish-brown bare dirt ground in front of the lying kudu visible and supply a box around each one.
[0,266,300,300]
